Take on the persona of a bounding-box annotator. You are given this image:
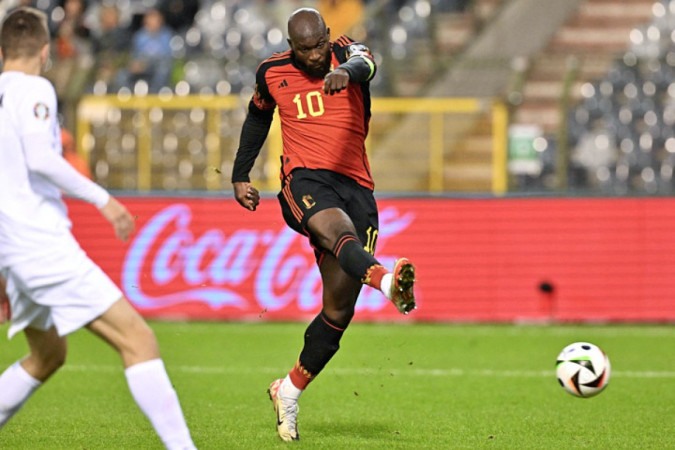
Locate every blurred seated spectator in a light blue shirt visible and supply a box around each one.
[118,8,174,93]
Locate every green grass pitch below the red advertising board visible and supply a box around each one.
[0,322,675,450]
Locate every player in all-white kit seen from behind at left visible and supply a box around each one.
[0,8,195,449]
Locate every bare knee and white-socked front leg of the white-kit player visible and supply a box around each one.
[87,299,195,450]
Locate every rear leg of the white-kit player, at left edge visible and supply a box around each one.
[0,327,66,428]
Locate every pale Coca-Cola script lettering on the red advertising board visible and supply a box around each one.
[122,203,414,311]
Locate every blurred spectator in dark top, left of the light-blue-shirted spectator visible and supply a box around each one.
[92,3,131,92]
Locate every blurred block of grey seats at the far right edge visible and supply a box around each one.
[568,0,675,195]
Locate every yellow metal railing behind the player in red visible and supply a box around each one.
[77,95,508,195]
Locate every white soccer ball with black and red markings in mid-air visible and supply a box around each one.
[556,342,611,397]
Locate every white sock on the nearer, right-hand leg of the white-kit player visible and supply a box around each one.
[124,359,196,450]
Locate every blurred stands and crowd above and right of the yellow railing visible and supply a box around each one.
[0,0,675,195]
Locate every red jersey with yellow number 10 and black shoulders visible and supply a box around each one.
[252,36,374,189]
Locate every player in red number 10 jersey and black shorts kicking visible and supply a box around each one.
[232,8,415,441]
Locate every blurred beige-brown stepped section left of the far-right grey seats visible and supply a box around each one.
[509,0,654,190]
